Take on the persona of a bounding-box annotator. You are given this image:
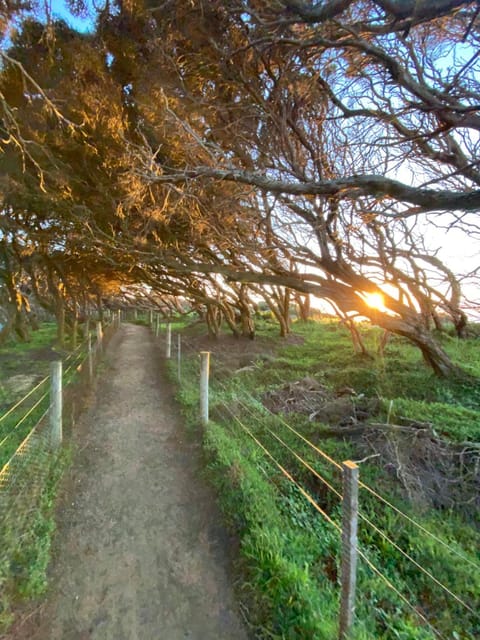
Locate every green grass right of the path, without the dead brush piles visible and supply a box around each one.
[166,322,480,640]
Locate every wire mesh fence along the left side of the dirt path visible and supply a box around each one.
[0,316,116,623]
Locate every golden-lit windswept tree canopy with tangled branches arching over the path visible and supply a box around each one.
[2,0,480,375]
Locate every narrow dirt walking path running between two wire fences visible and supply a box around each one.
[15,325,247,640]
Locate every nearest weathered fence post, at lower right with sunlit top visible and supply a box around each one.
[338,460,359,640]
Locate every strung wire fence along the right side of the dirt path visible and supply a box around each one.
[152,320,480,639]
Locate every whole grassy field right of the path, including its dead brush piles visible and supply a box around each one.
[170,320,480,640]
